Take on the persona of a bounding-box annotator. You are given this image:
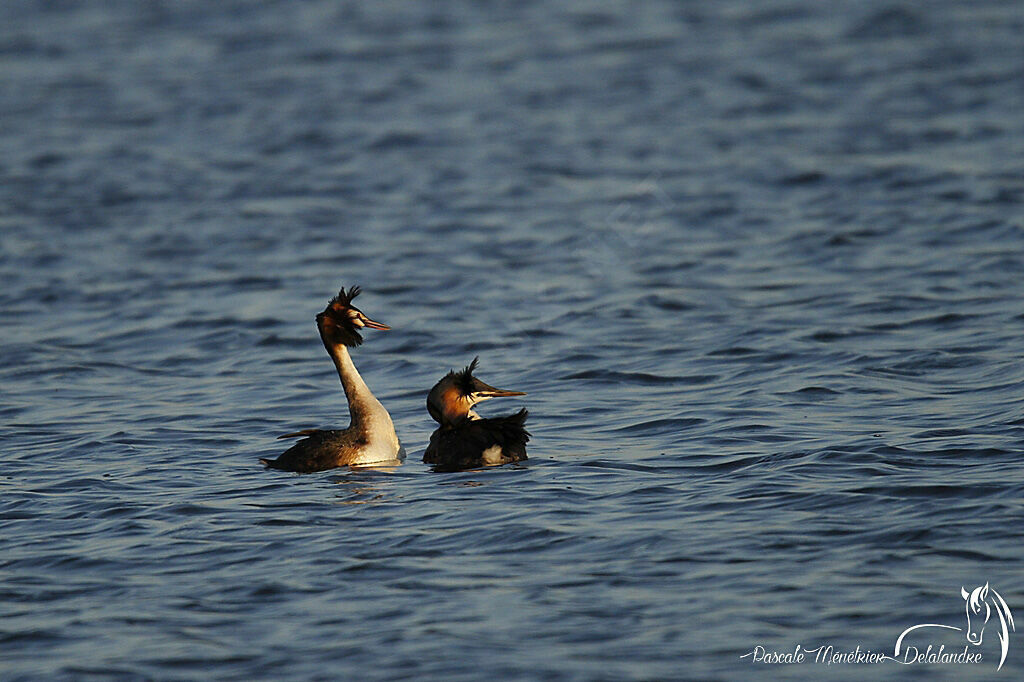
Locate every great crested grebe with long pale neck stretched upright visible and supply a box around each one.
[260,287,402,473]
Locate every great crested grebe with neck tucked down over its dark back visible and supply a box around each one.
[423,357,529,471]
